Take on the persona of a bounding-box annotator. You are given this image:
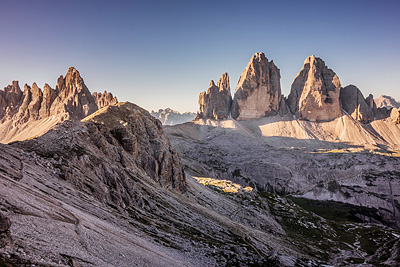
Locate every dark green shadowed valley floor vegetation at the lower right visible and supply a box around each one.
[259,192,400,266]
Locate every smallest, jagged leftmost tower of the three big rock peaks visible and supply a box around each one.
[196,73,232,120]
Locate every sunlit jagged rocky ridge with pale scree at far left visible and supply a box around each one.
[0,67,118,143]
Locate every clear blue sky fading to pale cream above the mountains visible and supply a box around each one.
[0,0,400,112]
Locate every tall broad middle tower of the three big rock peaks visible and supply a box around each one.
[231,53,282,120]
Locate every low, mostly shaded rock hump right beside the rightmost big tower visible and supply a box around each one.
[340,85,374,124]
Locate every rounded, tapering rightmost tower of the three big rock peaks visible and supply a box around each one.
[288,55,342,122]
